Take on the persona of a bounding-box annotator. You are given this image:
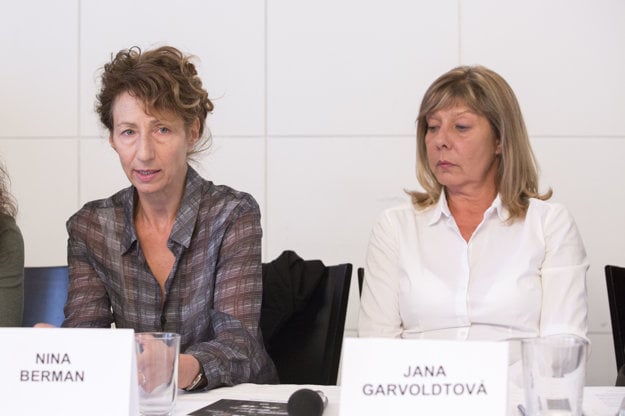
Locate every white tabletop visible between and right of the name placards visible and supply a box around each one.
[174,384,625,416]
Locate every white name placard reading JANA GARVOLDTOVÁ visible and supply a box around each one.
[340,338,508,416]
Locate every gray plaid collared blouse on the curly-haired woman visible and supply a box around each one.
[63,167,277,388]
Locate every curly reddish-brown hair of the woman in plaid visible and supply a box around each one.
[96,46,213,153]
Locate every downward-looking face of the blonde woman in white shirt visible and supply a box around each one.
[425,104,501,195]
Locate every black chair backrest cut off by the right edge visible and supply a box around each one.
[605,265,625,370]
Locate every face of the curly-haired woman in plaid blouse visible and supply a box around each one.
[109,92,198,202]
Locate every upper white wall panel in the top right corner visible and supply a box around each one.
[460,0,625,136]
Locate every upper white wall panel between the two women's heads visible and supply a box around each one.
[267,0,458,135]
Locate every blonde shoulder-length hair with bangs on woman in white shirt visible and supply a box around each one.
[408,66,552,221]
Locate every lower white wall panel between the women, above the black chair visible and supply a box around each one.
[266,137,416,330]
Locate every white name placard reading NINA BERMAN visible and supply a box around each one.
[0,328,138,416]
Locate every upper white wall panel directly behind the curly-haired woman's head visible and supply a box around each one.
[80,0,265,135]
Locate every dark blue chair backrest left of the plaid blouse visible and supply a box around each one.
[22,266,68,326]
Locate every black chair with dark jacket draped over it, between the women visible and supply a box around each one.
[260,251,352,385]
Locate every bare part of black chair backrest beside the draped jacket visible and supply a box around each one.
[261,255,352,385]
